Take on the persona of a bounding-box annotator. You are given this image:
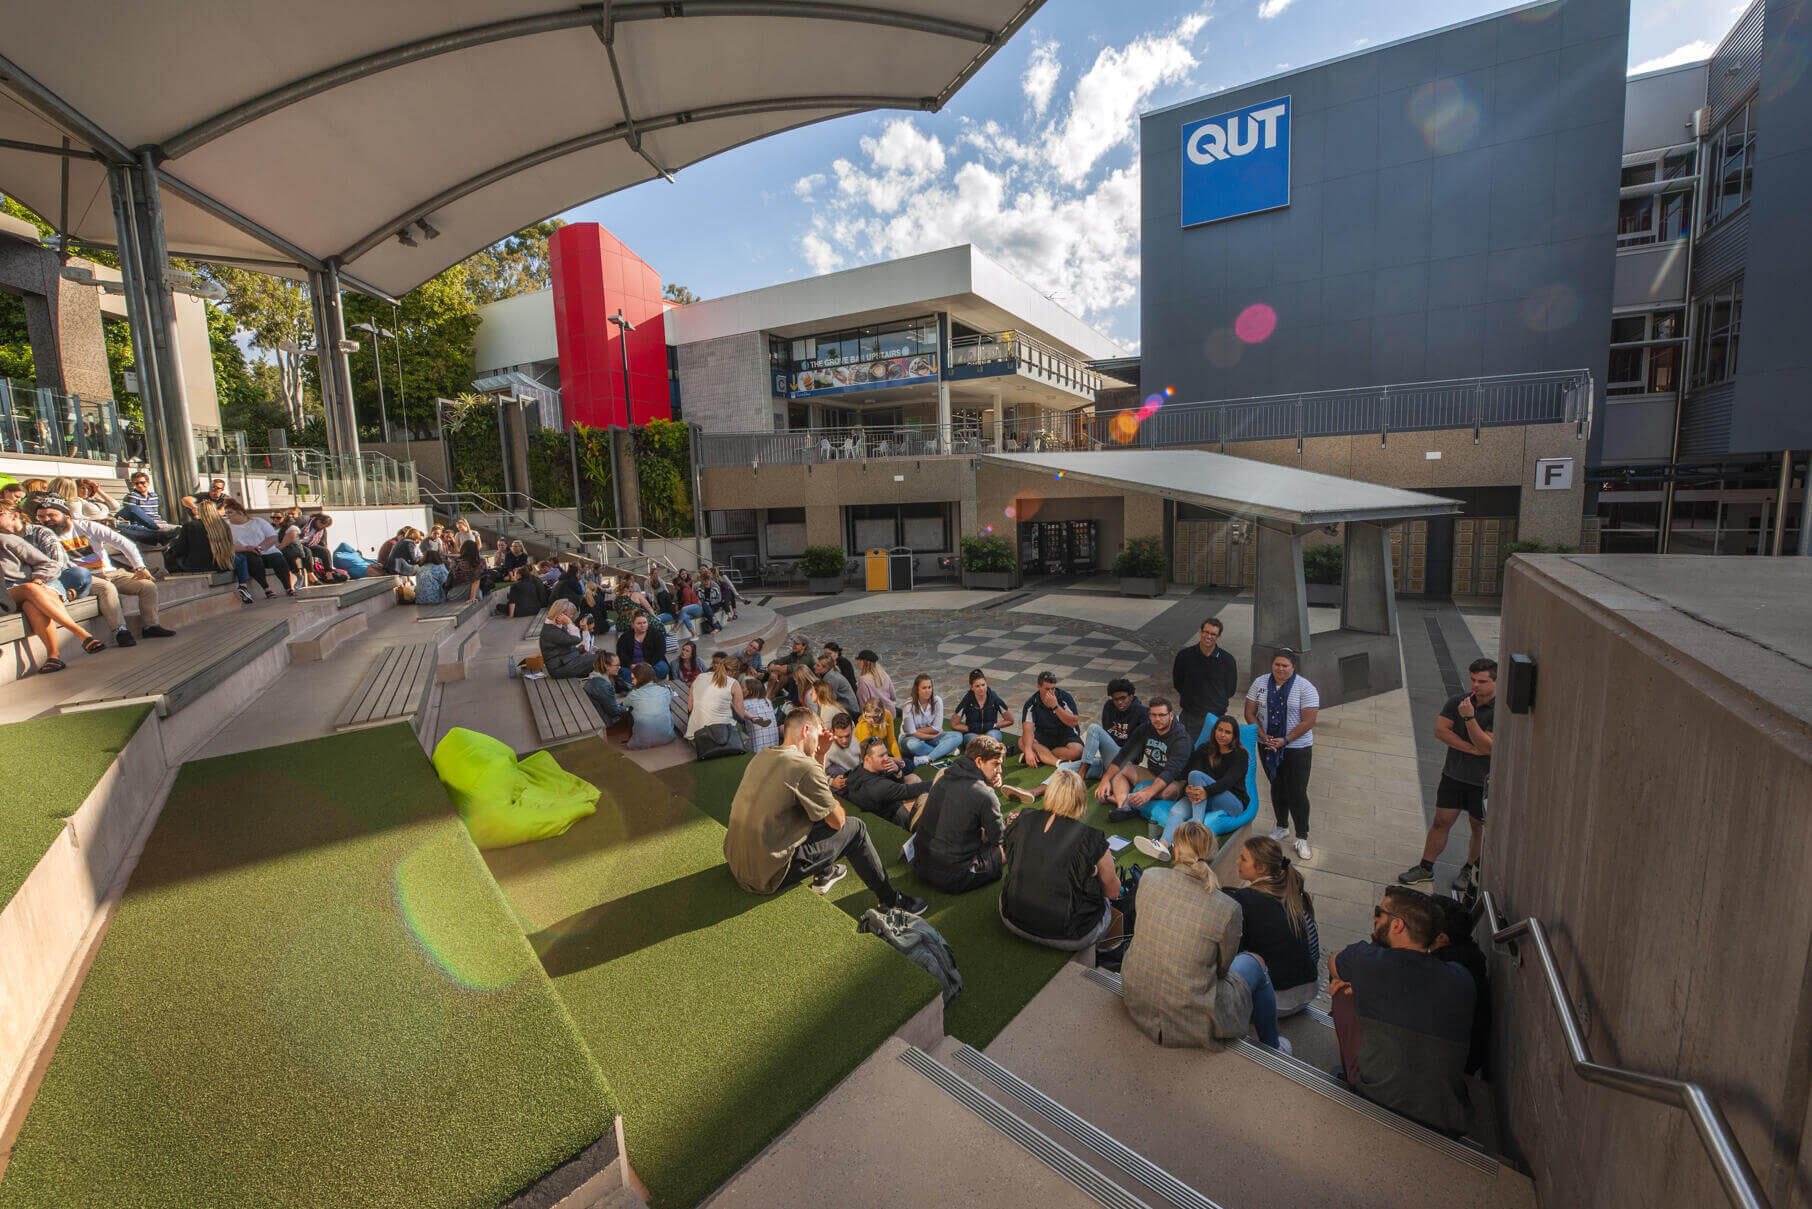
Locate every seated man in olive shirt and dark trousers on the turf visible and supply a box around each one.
[723,709,930,915]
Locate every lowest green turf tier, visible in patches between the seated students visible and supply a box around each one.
[660,756,1151,1049]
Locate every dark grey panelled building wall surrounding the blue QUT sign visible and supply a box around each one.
[1140,0,1629,411]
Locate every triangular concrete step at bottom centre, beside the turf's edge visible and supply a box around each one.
[705,1037,1147,1209]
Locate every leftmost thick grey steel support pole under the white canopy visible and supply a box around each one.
[107,154,198,524]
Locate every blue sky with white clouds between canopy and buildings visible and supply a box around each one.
[565,0,1745,348]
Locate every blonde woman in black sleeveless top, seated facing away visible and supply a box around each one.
[1000,769,1120,953]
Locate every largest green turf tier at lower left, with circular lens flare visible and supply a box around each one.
[0,725,618,1209]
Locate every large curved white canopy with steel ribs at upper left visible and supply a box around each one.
[0,0,1042,295]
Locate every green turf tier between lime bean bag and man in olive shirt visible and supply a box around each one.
[484,740,937,1209]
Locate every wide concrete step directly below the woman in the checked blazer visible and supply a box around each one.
[971,964,1535,1209]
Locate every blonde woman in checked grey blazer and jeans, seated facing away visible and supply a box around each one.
[1120,819,1290,1053]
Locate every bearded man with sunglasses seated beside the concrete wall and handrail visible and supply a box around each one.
[1328,886,1477,1136]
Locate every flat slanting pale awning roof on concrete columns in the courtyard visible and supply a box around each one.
[980,450,1460,527]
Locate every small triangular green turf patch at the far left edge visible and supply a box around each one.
[0,705,150,906]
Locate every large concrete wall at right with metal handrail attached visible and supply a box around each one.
[1484,555,1812,1209]
